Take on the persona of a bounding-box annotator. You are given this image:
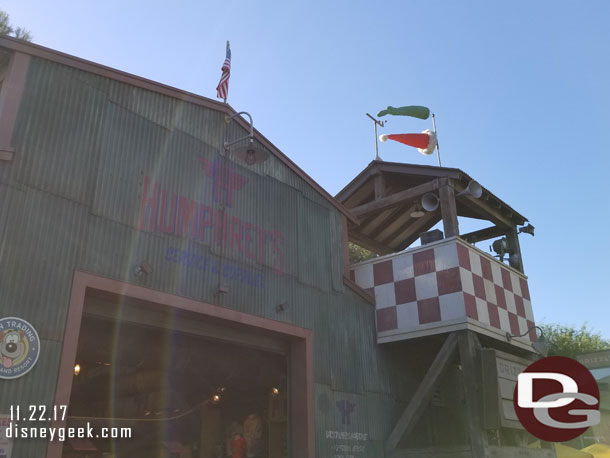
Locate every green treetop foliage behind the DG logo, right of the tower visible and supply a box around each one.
[540,323,610,358]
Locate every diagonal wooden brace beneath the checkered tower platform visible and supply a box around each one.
[385,333,457,457]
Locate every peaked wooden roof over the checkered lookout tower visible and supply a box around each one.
[335,161,527,254]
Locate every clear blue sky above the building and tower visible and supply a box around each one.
[0,0,610,338]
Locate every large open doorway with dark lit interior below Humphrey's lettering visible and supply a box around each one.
[63,298,288,458]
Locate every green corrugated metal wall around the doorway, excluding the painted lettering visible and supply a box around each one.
[0,53,418,458]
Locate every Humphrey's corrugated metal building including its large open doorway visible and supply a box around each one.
[0,37,550,458]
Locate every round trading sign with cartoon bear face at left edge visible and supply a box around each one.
[0,317,40,379]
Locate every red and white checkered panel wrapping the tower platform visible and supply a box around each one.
[351,240,536,340]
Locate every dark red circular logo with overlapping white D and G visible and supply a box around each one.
[513,356,600,442]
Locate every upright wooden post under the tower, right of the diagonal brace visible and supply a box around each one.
[458,331,488,458]
